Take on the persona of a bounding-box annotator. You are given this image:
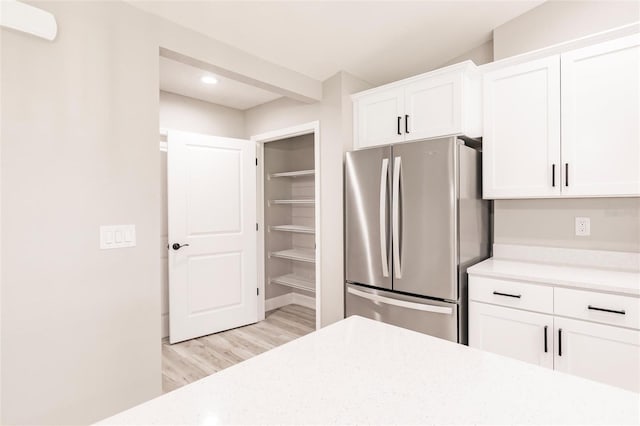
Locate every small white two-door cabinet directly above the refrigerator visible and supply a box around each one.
[352,61,482,149]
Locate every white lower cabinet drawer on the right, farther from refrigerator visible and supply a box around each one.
[554,288,640,330]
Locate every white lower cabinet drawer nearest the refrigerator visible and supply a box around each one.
[469,276,553,313]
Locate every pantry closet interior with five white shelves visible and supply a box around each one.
[264,136,316,297]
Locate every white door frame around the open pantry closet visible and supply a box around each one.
[249,120,322,330]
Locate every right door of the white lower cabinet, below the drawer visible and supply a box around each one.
[554,317,640,392]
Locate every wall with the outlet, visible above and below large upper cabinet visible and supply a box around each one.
[493,1,640,252]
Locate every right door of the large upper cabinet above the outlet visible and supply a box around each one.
[562,35,640,196]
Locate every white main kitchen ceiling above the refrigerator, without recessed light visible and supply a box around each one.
[131,0,543,85]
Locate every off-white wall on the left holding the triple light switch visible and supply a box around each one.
[1,2,161,424]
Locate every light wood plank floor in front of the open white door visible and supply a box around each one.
[162,305,316,393]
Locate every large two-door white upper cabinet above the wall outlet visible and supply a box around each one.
[483,35,640,198]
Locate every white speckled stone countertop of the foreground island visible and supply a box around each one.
[100,316,640,425]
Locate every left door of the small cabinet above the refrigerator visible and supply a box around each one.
[354,88,404,148]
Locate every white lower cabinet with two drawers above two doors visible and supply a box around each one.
[469,275,640,392]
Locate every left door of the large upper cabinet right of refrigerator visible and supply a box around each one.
[483,56,560,198]
